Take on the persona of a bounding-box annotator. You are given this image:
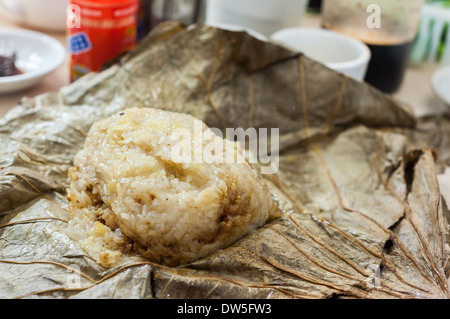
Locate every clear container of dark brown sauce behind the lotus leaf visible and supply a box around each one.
[322,0,424,93]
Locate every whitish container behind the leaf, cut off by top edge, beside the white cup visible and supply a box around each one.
[205,0,309,37]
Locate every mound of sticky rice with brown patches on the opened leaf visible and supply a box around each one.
[68,108,277,266]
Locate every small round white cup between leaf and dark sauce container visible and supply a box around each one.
[270,28,371,81]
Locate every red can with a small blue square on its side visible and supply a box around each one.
[67,0,139,81]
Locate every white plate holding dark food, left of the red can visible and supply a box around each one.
[0,29,66,93]
